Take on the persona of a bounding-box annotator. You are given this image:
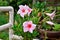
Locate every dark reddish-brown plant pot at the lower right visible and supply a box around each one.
[39,29,60,39]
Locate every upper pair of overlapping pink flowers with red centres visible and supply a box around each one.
[17,5,32,18]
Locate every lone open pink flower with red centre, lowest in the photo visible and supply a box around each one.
[23,21,36,33]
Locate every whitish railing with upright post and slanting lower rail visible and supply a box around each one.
[0,6,23,40]
